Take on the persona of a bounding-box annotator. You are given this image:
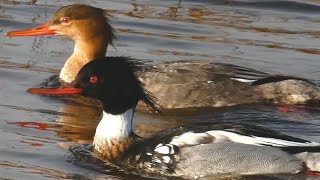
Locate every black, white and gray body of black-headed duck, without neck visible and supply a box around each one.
[115,123,320,178]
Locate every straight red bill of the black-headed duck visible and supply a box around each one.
[27,87,82,95]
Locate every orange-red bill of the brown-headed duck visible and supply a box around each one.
[5,24,57,36]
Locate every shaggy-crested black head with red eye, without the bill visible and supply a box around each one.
[75,57,157,114]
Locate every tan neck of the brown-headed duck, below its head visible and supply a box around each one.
[60,39,108,83]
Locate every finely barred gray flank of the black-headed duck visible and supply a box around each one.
[175,142,303,178]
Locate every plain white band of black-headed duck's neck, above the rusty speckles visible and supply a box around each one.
[93,108,134,151]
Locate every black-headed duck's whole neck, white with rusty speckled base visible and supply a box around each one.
[93,108,134,159]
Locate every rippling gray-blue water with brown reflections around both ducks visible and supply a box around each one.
[0,0,320,179]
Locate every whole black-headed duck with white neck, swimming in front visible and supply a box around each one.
[28,57,320,178]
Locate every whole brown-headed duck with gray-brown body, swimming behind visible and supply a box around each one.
[6,5,320,109]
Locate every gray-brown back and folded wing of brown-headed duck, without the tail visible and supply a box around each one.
[138,61,267,109]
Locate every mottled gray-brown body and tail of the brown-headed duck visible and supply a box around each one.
[138,61,320,109]
